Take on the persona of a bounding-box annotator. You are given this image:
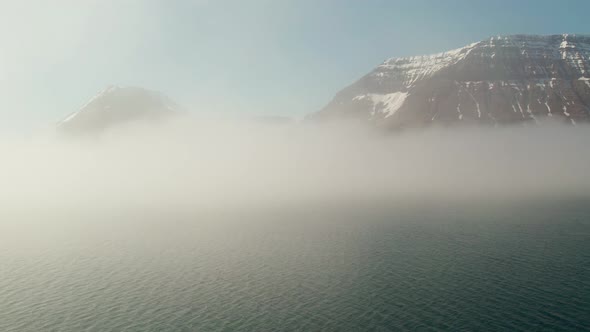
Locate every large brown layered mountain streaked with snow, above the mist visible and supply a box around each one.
[309,34,590,129]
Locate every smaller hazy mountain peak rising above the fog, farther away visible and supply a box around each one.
[57,86,180,134]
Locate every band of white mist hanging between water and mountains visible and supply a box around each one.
[0,119,590,219]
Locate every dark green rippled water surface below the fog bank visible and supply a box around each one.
[0,201,590,332]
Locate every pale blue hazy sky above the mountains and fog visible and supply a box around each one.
[0,0,590,130]
